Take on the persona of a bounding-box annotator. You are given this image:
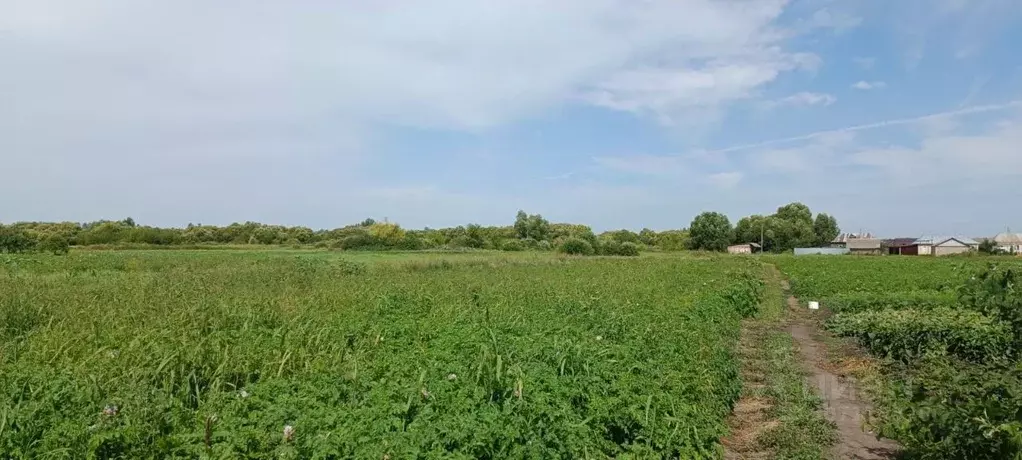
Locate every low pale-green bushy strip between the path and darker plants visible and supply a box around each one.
[828,308,1013,363]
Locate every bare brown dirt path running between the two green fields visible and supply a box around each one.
[781,280,899,460]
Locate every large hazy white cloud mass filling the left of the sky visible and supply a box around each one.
[0,0,819,225]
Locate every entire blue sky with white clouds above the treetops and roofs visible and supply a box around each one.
[0,0,1022,236]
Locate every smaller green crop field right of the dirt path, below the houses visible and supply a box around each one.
[769,257,1022,459]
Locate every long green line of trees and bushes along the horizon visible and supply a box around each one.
[0,203,837,256]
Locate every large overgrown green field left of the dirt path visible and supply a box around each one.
[0,250,761,459]
